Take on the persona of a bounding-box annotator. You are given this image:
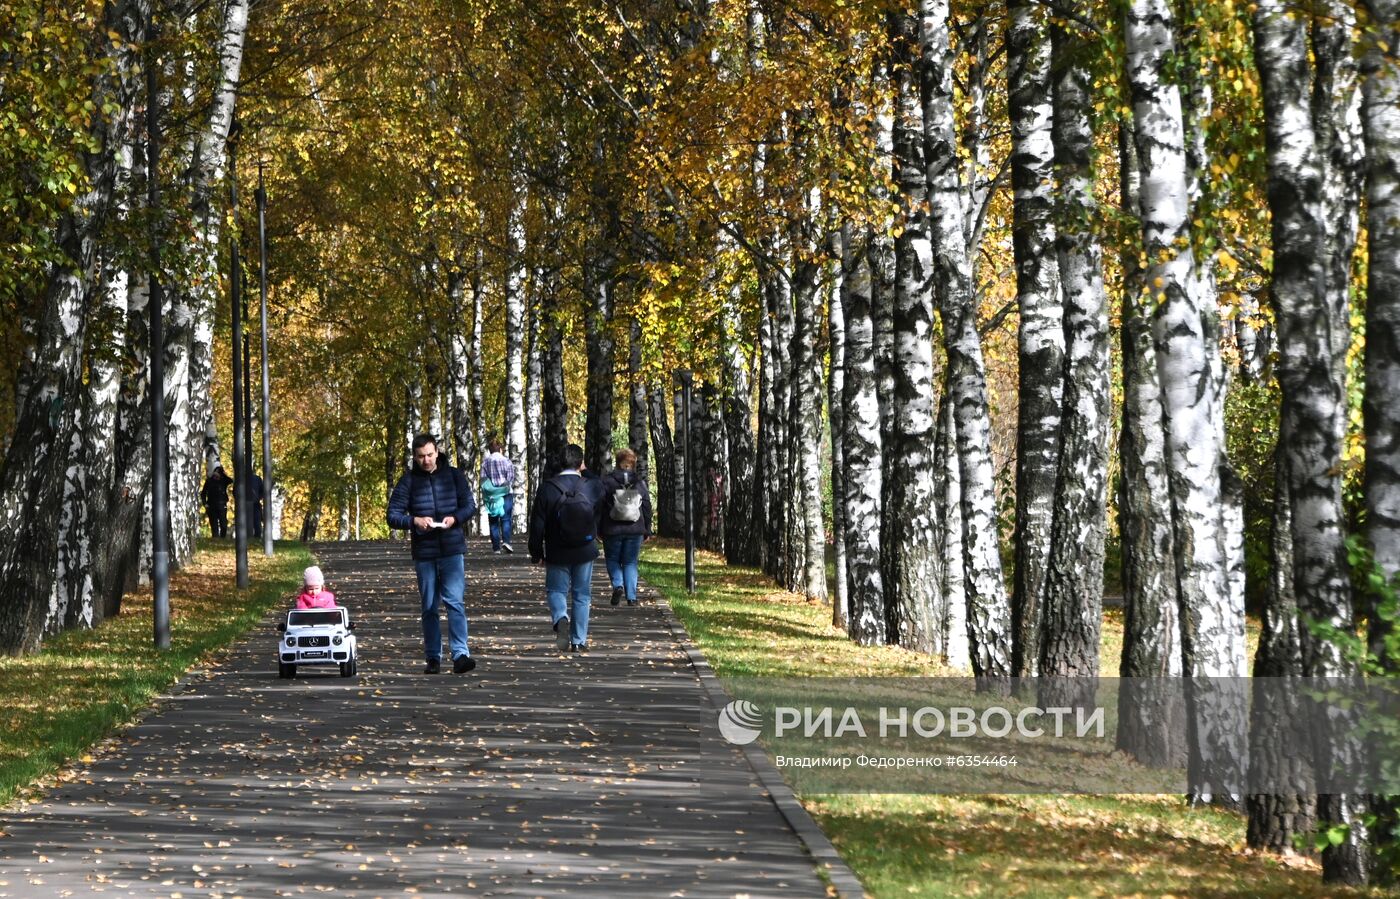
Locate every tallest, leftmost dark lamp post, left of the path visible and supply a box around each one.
[146,11,171,650]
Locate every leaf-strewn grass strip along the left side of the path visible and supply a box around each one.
[0,541,311,805]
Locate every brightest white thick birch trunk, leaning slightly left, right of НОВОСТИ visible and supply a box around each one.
[1124,0,1246,798]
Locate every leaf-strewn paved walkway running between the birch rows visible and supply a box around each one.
[0,541,848,898]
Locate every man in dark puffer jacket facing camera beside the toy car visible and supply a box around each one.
[386,434,476,674]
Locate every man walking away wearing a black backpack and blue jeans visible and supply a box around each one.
[529,444,603,653]
